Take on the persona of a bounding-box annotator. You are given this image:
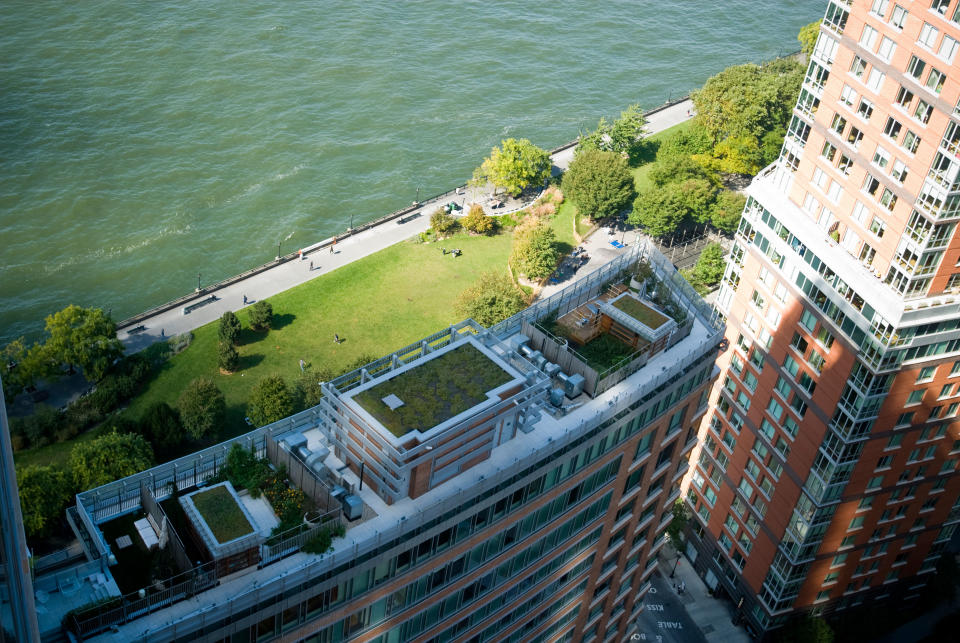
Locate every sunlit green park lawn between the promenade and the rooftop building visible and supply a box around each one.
[125,229,511,440]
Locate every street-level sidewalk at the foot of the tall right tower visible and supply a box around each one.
[659,542,753,643]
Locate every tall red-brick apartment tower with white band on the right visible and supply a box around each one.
[687,0,960,633]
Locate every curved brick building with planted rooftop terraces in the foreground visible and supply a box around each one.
[47,245,722,643]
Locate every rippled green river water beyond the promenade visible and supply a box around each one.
[0,0,825,341]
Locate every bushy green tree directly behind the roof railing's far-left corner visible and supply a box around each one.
[69,431,153,491]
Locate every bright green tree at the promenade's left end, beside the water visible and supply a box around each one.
[43,304,123,381]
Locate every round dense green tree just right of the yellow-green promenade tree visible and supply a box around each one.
[563,149,637,219]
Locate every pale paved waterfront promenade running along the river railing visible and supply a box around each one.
[117,100,693,352]
